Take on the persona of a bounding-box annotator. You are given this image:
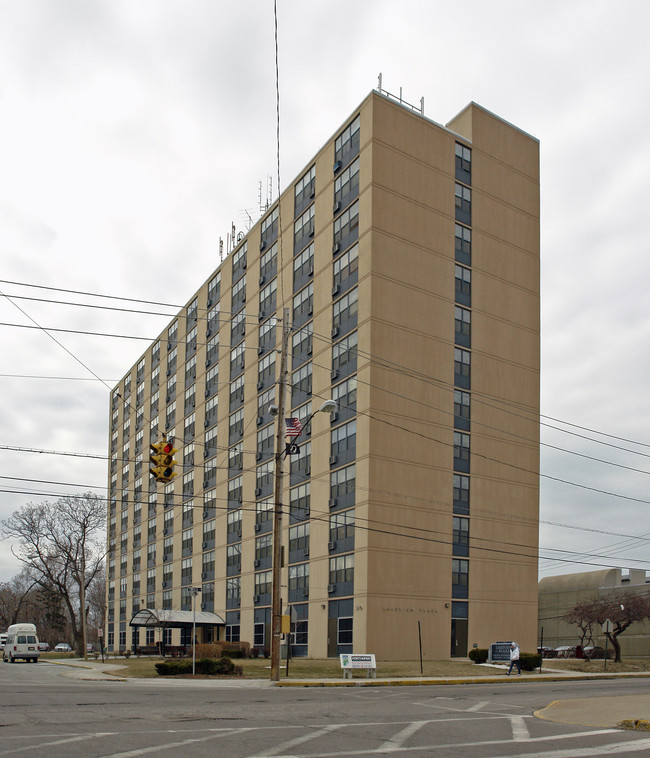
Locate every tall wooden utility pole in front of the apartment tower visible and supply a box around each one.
[271,308,291,682]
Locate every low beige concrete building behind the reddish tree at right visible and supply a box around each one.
[538,569,650,659]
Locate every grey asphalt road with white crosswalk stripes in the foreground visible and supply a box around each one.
[0,663,650,758]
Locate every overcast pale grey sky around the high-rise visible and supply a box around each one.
[0,0,650,580]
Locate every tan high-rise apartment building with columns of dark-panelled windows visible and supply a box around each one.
[107,87,540,659]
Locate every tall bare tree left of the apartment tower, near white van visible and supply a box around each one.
[2,492,106,655]
